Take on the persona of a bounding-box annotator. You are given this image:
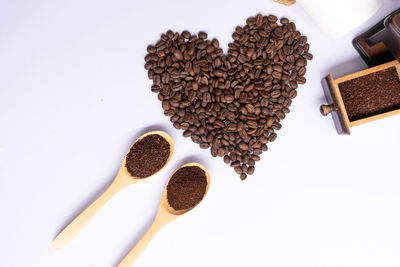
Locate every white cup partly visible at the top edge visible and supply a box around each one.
[297,0,383,39]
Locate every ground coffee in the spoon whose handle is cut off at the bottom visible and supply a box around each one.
[167,166,207,210]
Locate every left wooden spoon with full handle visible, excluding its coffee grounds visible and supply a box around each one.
[53,131,174,249]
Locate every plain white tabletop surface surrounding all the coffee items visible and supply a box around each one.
[0,0,400,267]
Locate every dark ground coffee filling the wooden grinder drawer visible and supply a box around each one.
[339,67,400,121]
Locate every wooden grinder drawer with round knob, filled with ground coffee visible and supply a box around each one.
[321,60,400,134]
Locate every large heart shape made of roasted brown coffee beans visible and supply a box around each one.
[145,14,312,179]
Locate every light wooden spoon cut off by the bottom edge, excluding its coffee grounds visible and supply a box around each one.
[118,162,210,267]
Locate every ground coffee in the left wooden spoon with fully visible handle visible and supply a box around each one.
[125,134,170,178]
